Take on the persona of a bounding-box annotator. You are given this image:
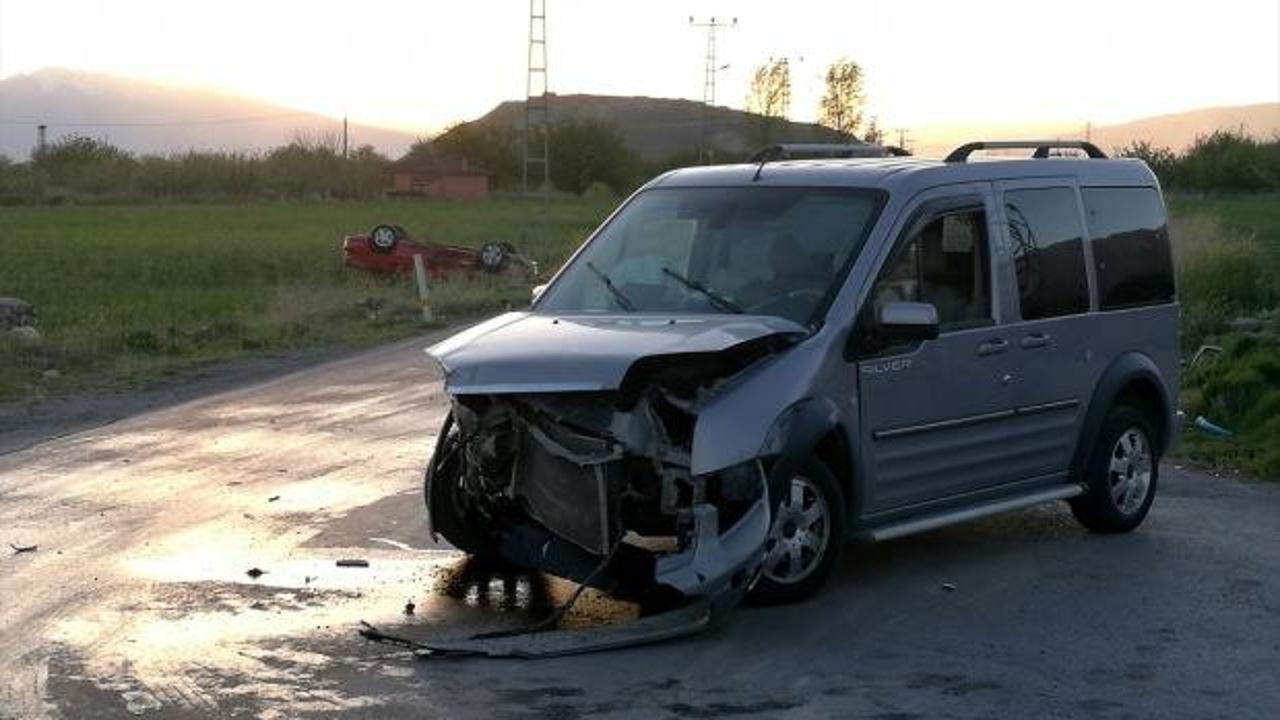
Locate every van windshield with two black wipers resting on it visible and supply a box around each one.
[535,187,883,324]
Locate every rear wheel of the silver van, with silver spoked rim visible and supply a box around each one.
[1070,405,1160,533]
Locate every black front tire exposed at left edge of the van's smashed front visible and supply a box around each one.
[422,414,498,557]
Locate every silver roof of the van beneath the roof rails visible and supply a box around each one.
[649,158,1157,192]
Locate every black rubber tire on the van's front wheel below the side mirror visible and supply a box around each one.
[748,457,845,605]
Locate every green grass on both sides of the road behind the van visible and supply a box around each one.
[0,195,1280,477]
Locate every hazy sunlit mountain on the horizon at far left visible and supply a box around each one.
[0,68,413,159]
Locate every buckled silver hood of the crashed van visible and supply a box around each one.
[426,311,808,395]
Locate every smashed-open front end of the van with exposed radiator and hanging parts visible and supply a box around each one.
[426,336,790,600]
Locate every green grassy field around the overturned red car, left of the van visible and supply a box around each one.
[0,199,614,401]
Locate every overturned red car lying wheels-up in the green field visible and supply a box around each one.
[342,224,538,279]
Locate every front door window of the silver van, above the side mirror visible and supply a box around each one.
[872,209,991,331]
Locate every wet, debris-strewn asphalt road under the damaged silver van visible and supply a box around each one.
[0,333,1280,719]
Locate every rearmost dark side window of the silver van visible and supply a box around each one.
[1080,187,1174,310]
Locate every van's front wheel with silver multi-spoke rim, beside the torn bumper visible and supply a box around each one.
[748,457,845,605]
